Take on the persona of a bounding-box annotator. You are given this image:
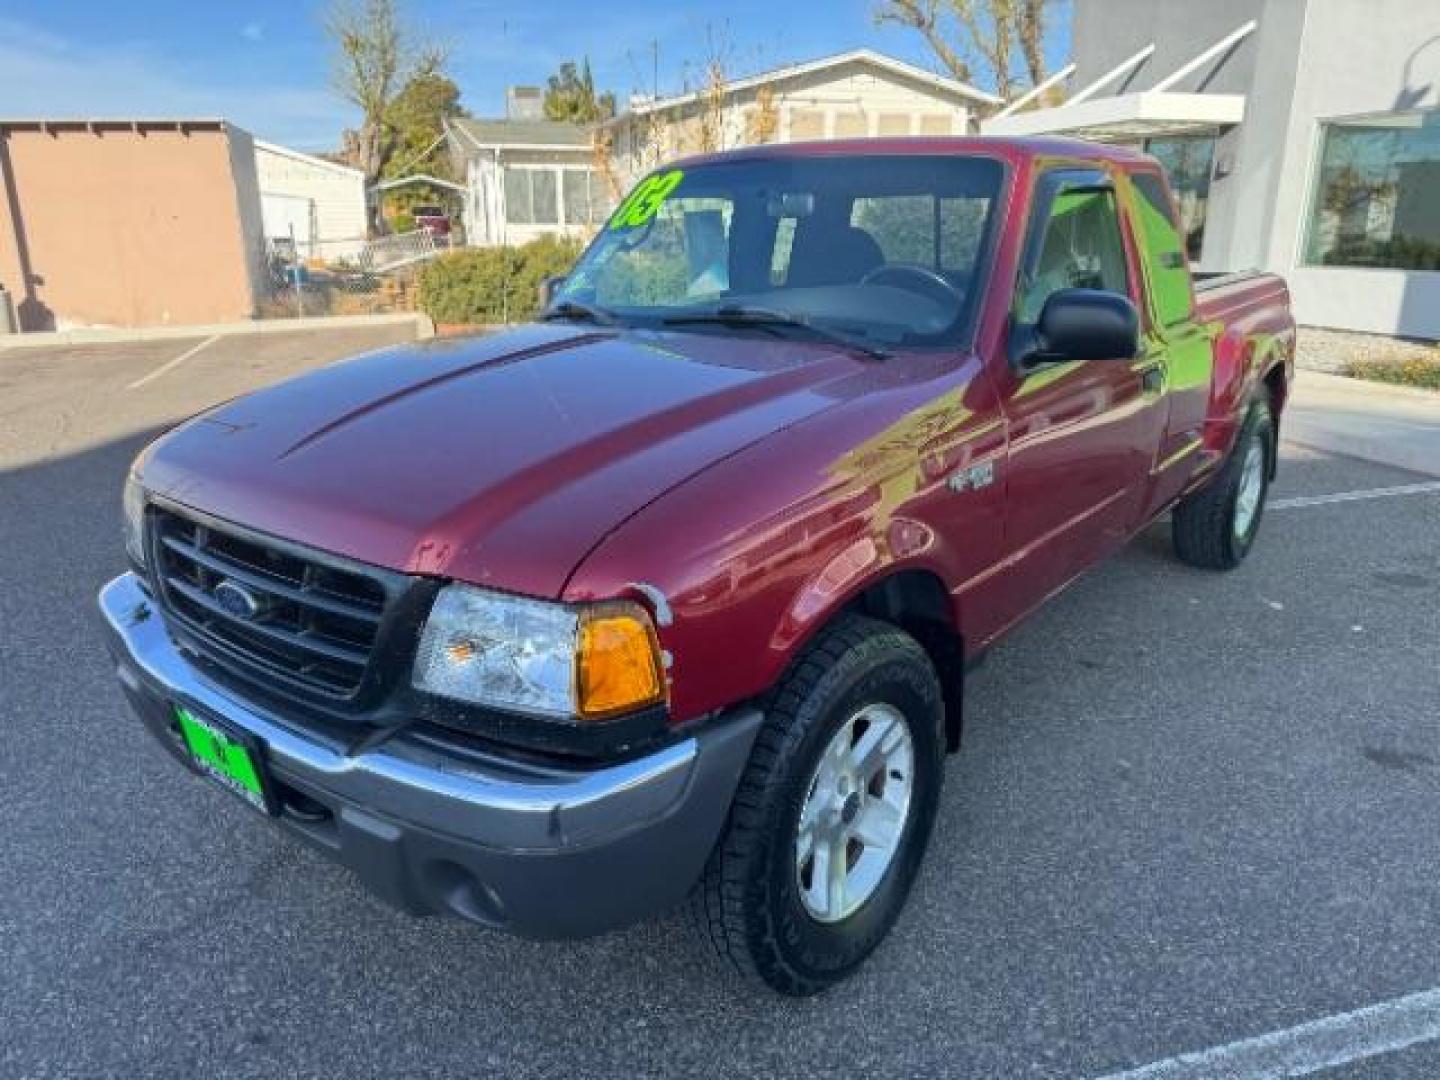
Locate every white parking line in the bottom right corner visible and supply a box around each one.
[1102,989,1440,1080]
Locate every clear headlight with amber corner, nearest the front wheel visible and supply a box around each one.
[413,585,665,720]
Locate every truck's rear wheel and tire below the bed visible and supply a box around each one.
[1171,400,1274,570]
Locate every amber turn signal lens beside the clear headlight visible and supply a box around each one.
[576,603,665,720]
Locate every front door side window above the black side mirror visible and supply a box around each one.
[1015,189,1130,323]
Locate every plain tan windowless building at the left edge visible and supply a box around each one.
[0,122,261,330]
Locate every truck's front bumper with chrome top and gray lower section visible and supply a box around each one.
[99,575,760,937]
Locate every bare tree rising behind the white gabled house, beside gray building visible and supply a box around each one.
[876,0,1054,98]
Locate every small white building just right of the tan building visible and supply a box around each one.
[255,140,366,259]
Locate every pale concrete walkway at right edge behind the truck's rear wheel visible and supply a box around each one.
[1280,370,1440,477]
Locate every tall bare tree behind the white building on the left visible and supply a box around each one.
[325,0,445,235]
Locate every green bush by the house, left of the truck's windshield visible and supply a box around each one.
[420,236,580,324]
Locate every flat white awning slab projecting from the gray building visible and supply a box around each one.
[981,91,1246,143]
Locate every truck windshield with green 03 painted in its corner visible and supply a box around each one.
[554,156,1002,346]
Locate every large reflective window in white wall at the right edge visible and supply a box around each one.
[1305,109,1440,271]
